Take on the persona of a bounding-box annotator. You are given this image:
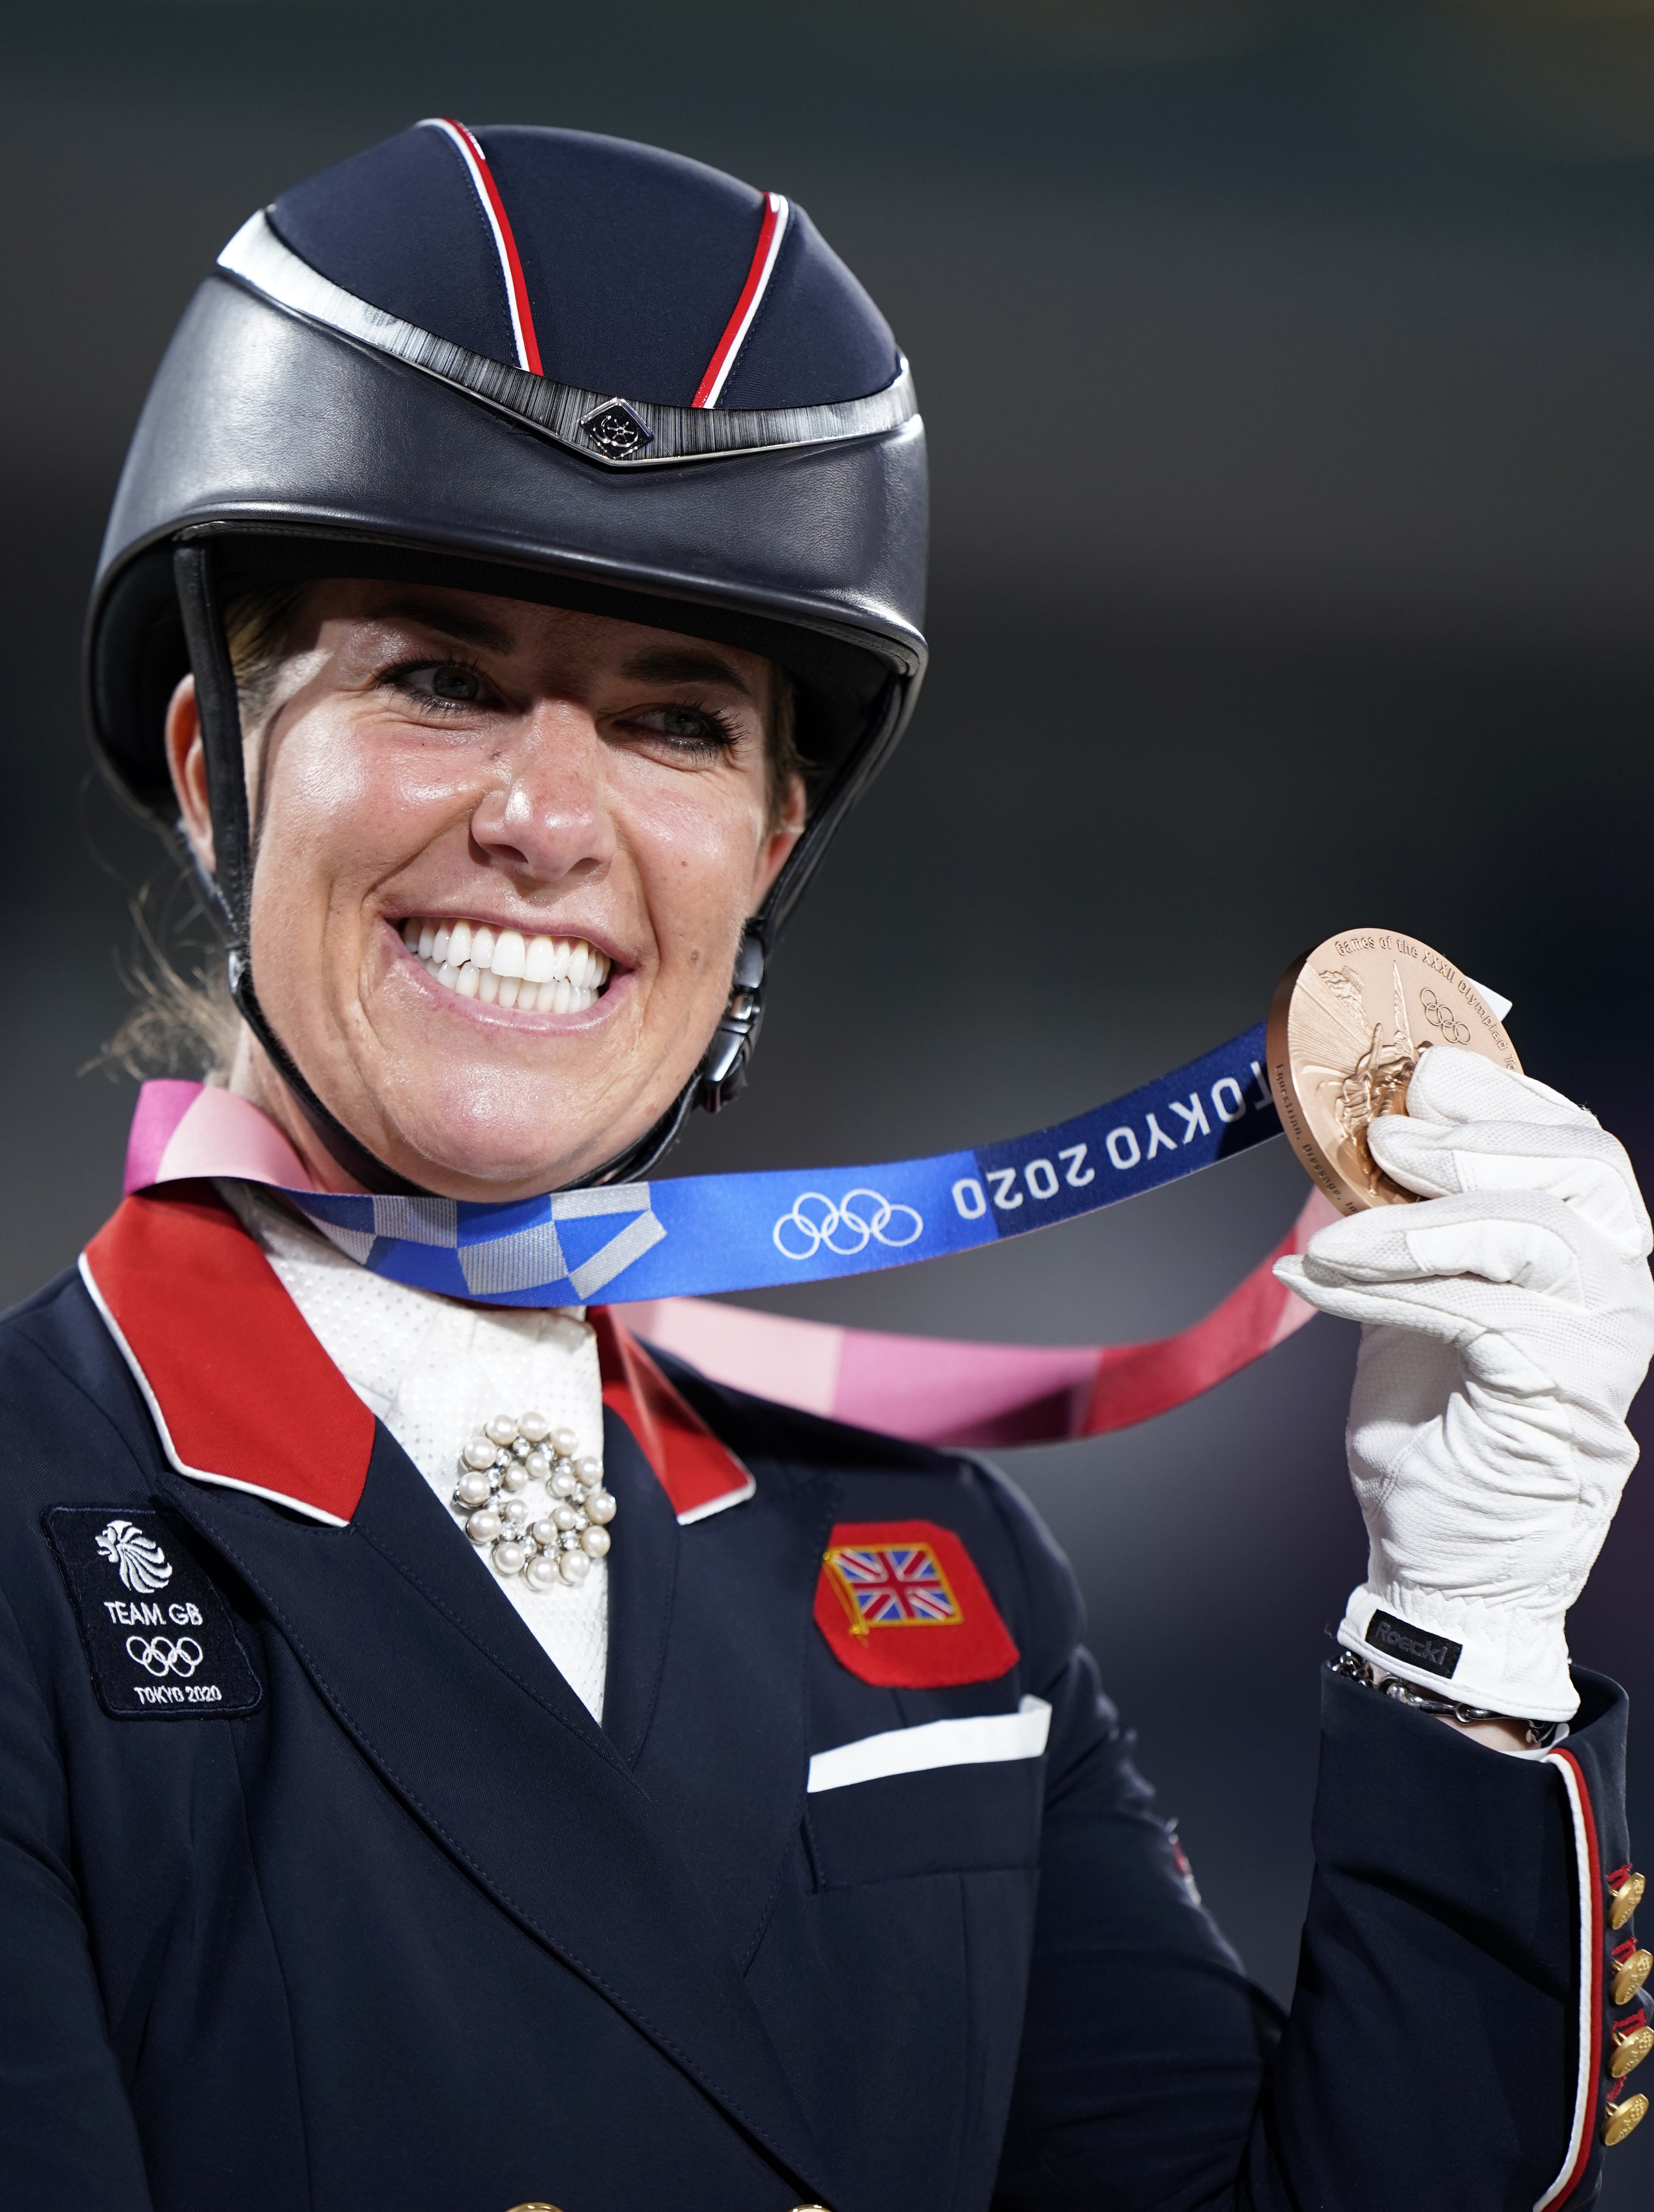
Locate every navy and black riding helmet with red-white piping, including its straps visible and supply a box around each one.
[86,119,927,1190]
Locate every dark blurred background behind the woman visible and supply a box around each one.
[0,0,1654,2212]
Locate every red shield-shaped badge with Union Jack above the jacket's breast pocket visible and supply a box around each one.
[816,1522,1017,1690]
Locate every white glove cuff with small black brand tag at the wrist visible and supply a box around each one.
[1338,1584,1579,1721]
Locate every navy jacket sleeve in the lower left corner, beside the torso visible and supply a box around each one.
[0,1597,150,2212]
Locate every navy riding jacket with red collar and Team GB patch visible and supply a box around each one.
[0,1190,1643,2212]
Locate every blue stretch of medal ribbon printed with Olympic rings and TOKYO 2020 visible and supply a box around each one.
[287,1024,1280,1305]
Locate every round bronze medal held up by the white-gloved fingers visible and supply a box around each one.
[1267,929,1521,1214]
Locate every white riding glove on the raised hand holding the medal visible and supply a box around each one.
[1276,1044,1654,1721]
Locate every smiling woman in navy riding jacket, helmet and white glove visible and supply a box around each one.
[0,124,1654,2212]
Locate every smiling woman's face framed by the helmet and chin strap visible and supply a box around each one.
[168,582,803,1199]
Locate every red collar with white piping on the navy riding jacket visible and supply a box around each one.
[79,1183,754,1528]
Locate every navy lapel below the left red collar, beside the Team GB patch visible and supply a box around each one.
[166,1429,825,2190]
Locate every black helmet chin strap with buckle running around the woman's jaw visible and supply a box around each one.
[172,535,738,1197]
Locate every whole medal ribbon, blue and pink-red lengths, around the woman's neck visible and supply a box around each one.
[126,1026,1333,1447]
